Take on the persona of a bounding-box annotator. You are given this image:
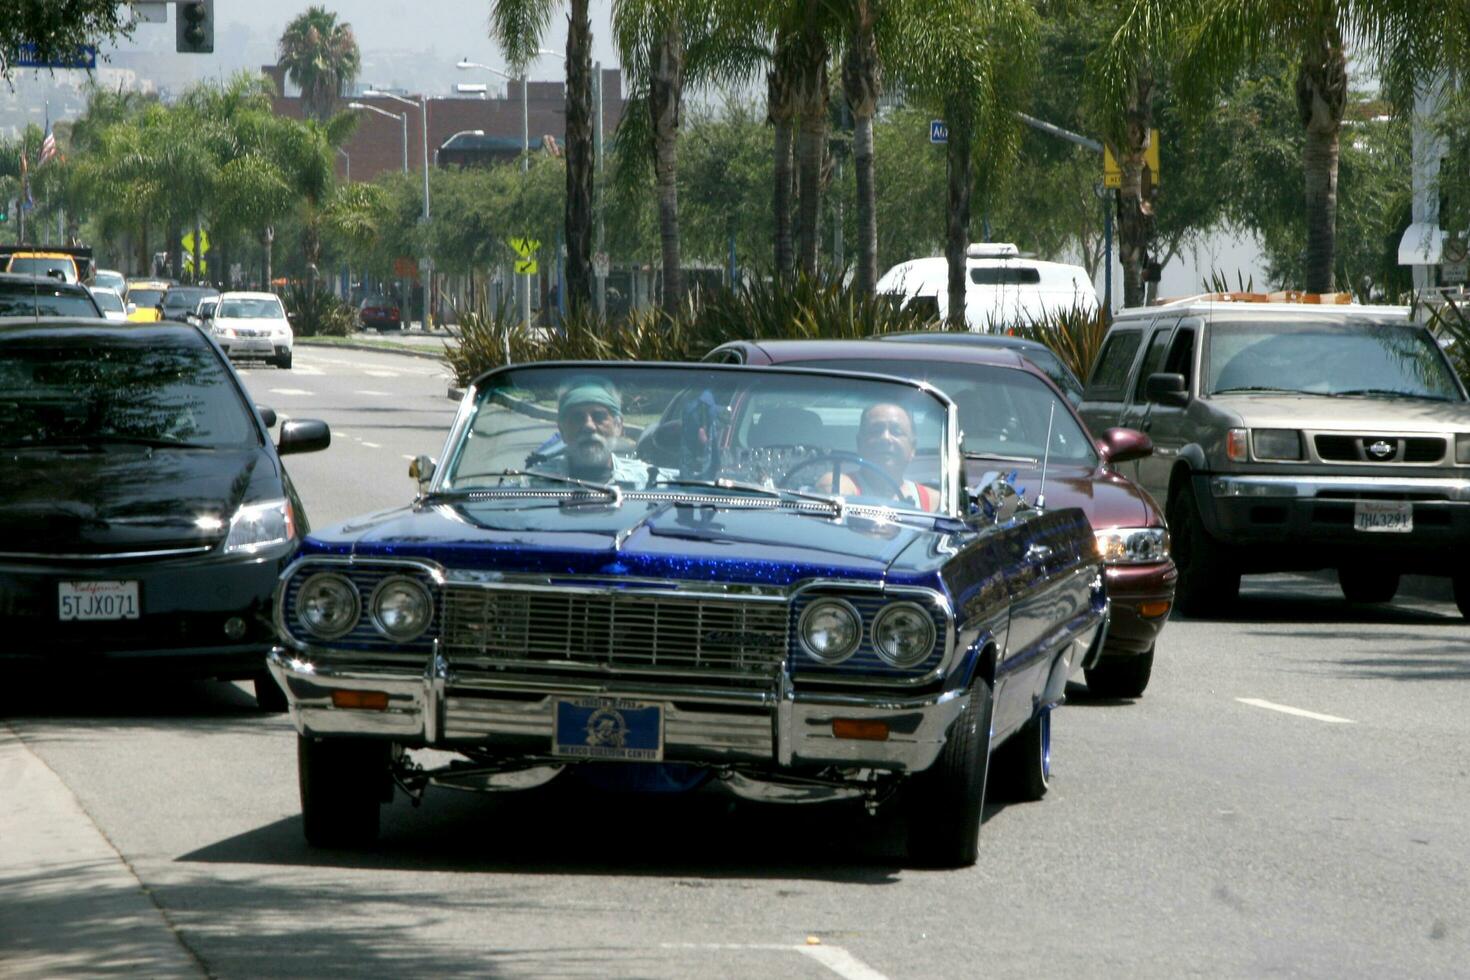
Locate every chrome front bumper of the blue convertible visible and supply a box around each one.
[268,646,970,773]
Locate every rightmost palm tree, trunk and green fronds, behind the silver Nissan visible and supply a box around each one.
[1176,0,1467,292]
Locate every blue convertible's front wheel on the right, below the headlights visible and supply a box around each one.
[906,680,994,868]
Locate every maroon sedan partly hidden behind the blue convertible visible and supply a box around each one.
[704,341,1177,698]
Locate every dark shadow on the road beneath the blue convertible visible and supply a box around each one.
[176,780,1005,884]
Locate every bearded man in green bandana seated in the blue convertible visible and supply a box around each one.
[529,375,660,489]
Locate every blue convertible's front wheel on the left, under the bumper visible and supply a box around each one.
[295,735,391,848]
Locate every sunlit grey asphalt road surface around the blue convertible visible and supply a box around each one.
[0,348,1470,980]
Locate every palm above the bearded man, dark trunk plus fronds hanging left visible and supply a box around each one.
[490,0,597,306]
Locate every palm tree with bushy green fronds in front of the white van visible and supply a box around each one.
[894,0,1039,329]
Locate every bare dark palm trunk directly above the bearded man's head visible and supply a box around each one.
[562,0,597,313]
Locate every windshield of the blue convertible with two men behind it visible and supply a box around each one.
[437,363,954,511]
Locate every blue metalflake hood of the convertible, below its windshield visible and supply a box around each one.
[303,500,963,586]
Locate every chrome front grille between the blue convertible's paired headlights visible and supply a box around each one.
[440,586,788,677]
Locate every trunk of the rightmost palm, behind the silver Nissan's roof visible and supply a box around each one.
[1297,26,1348,292]
